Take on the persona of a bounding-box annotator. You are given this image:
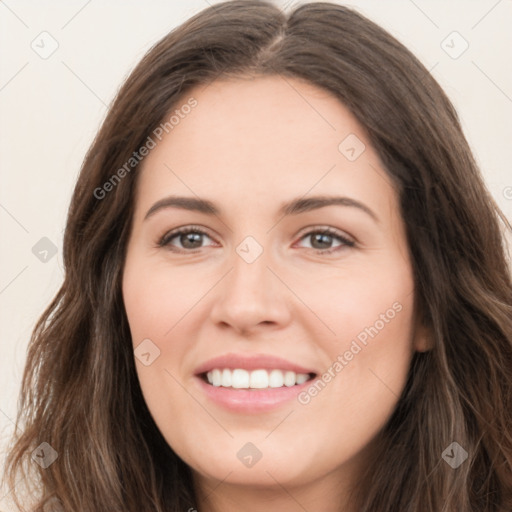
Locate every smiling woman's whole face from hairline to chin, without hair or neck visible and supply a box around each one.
[123,76,426,496]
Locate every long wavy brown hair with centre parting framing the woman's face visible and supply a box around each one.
[6,0,512,512]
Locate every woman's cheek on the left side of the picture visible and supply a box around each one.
[123,254,211,440]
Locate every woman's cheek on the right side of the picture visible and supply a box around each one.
[299,265,414,434]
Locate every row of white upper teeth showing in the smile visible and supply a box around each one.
[206,368,309,389]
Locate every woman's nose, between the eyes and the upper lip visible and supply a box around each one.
[211,241,291,334]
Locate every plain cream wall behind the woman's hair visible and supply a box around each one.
[0,0,512,504]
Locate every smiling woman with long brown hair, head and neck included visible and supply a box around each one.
[8,1,512,512]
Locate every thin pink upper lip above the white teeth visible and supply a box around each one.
[195,353,316,375]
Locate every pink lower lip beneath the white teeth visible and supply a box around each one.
[195,376,312,413]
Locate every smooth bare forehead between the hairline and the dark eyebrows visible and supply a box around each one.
[134,76,391,218]
